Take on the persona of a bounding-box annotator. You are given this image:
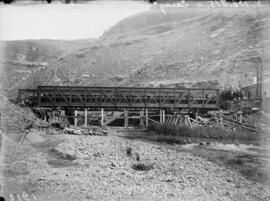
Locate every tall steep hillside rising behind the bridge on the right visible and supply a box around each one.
[51,10,267,87]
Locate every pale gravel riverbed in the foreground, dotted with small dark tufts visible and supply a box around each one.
[3,129,270,201]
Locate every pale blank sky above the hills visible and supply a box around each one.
[0,0,151,41]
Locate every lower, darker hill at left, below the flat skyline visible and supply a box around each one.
[0,39,92,97]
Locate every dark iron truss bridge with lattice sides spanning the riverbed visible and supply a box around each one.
[18,86,219,109]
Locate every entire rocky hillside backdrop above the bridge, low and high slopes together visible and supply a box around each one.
[1,9,269,99]
